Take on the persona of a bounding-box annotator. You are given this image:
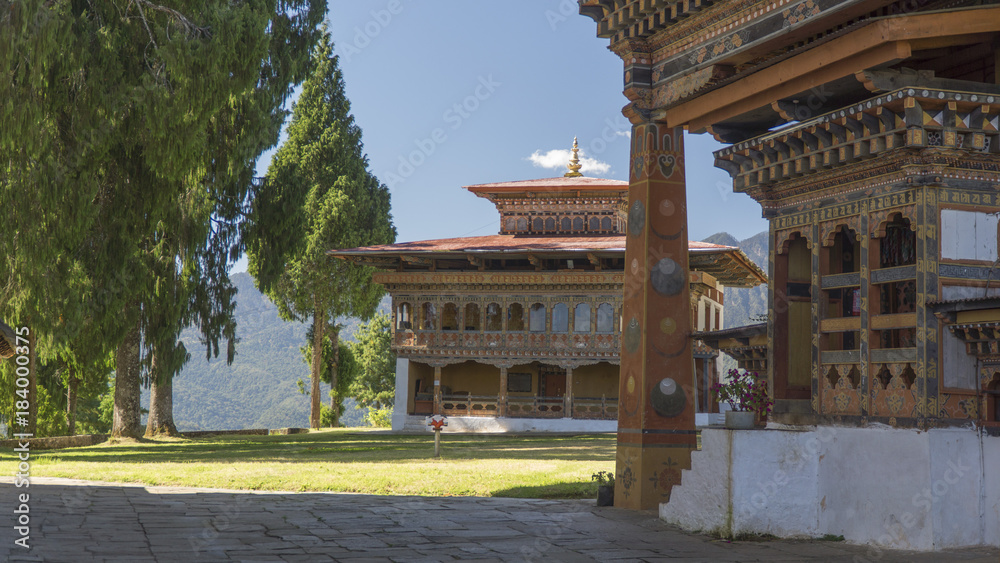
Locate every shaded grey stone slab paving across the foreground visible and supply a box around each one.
[0,478,1000,563]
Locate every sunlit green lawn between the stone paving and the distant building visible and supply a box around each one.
[9,429,615,498]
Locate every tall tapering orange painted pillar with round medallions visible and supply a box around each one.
[615,123,697,509]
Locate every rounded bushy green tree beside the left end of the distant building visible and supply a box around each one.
[350,313,396,409]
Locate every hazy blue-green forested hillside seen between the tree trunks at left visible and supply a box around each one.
[143,273,389,432]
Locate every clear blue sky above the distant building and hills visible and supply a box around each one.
[236,0,767,271]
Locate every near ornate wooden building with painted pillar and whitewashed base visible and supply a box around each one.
[579,0,1000,549]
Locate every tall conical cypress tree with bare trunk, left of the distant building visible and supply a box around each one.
[247,26,396,428]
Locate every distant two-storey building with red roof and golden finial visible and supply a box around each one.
[330,140,766,432]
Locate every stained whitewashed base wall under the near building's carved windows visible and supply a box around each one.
[660,427,1000,551]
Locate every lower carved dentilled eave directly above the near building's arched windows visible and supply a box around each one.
[715,85,1000,216]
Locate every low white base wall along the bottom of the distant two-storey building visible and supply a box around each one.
[392,415,618,433]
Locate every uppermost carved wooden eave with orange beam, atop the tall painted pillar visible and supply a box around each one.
[580,0,1000,135]
